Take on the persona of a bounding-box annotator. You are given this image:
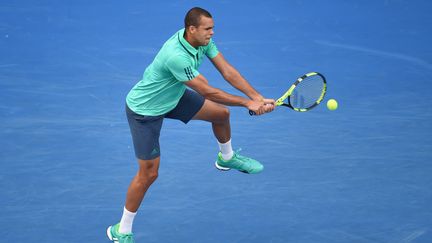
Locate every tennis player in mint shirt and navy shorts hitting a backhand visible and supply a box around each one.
[107,7,275,243]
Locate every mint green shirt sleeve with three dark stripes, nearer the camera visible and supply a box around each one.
[165,56,200,82]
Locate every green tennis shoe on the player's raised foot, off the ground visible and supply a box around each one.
[215,150,264,174]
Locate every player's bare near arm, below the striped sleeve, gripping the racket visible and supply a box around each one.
[185,74,265,115]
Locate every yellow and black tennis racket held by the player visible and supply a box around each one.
[249,72,327,116]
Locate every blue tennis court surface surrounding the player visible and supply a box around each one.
[0,0,432,243]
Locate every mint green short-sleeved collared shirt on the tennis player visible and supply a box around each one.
[126,29,219,116]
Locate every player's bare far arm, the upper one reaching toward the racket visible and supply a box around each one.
[210,52,274,104]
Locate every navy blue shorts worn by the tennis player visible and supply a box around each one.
[126,89,205,160]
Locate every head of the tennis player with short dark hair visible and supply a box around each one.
[185,7,214,46]
